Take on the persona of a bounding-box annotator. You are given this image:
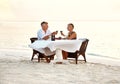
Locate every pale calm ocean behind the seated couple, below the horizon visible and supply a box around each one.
[0,21,120,60]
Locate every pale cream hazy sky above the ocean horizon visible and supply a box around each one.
[0,0,120,21]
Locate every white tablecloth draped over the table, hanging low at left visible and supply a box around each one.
[29,40,84,55]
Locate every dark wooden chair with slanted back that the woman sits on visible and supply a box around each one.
[68,39,89,64]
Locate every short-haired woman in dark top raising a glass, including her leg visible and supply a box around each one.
[61,23,77,59]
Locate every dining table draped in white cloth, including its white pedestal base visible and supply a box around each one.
[29,39,84,64]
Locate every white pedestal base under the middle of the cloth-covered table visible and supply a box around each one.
[51,48,69,64]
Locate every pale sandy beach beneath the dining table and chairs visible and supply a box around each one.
[0,49,120,84]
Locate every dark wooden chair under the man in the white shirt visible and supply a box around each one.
[30,37,54,63]
